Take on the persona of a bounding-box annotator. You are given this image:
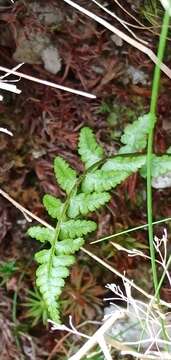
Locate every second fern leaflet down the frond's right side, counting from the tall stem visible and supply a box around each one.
[82,170,130,193]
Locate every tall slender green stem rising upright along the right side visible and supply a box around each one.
[147,11,169,296]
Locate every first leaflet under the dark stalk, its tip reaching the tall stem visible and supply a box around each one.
[101,155,146,173]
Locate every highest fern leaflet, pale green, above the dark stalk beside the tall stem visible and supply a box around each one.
[119,114,151,154]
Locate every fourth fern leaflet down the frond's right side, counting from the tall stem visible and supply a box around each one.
[60,220,97,240]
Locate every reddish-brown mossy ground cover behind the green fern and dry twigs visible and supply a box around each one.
[0,0,171,360]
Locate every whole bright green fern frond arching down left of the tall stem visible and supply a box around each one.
[28,118,171,323]
